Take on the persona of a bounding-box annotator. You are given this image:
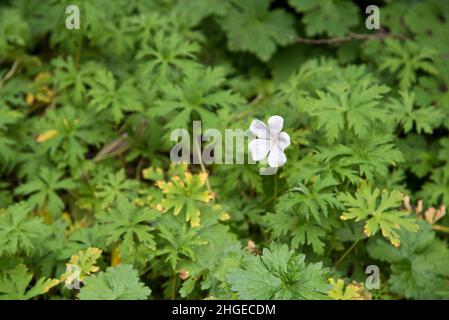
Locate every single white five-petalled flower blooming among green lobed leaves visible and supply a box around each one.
[248,116,290,168]
